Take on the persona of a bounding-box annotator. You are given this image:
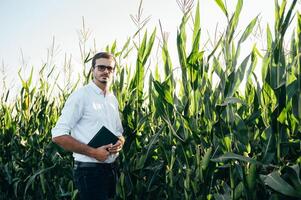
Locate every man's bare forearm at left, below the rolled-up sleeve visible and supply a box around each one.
[52,135,95,157]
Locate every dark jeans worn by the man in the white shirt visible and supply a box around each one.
[73,162,117,200]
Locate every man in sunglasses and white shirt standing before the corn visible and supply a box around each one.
[52,52,124,200]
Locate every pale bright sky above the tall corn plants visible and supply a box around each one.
[0,0,300,94]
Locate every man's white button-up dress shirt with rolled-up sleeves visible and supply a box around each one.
[52,82,123,163]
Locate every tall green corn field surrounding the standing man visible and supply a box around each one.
[0,0,301,200]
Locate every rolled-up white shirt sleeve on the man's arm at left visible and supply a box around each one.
[51,91,84,138]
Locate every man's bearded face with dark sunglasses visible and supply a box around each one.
[92,58,115,84]
